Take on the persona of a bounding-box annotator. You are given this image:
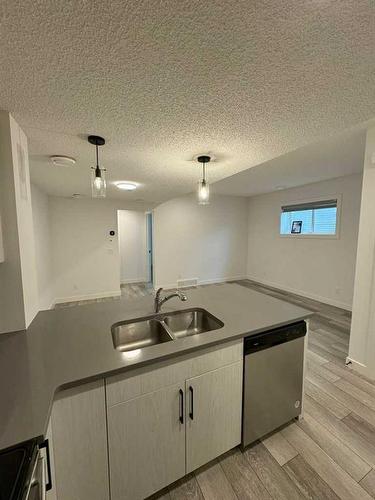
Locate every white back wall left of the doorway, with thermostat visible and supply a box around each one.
[49,197,152,302]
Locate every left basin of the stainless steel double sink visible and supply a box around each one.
[111,318,173,351]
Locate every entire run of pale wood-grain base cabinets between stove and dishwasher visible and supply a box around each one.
[47,340,243,500]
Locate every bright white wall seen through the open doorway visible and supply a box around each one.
[118,210,147,283]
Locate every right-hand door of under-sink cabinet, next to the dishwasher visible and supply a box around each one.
[186,361,242,473]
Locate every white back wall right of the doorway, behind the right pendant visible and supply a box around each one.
[154,195,247,287]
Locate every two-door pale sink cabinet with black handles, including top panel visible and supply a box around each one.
[106,341,243,500]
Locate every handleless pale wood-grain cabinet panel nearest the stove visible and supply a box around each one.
[52,380,109,500]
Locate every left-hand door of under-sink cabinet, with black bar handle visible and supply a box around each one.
[108,383,185,500]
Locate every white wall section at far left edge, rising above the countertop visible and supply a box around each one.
[0,111,38,333]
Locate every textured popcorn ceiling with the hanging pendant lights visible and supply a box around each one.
[0,0,375,202]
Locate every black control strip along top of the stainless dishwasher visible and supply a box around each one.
[244,321,307,356]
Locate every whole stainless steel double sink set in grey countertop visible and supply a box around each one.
[111,308,224,351]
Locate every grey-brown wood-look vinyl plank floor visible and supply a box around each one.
[55,280,375,500]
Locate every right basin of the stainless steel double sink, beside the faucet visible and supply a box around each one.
[163,309,224,339]
